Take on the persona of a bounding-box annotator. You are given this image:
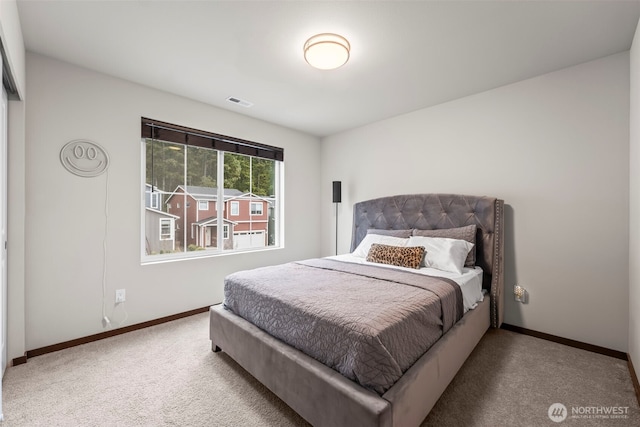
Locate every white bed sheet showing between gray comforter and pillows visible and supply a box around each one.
[327,253,484,313]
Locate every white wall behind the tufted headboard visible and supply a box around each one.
[322,53,629,351]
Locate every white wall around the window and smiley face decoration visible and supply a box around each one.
[25,53,320,350]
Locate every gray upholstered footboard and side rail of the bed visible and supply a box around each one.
[210,298,490,427]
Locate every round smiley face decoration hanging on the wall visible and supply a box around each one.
[60,139,109,178]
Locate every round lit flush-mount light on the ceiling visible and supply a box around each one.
[304,33,351,70]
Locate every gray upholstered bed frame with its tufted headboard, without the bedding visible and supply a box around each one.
[210,194,504,427]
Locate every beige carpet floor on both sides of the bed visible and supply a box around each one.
[2,314,640,427]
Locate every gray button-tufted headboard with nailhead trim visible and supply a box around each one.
[351,194,504,328]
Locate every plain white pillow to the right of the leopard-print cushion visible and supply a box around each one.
[407,236,473,274]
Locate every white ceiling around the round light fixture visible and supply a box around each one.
[18,0,640,137]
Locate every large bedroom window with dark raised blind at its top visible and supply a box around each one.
[141,118,284,262]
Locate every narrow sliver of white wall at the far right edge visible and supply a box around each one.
[629,20,640,374]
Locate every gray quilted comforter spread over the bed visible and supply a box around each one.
[224,259,463,394]
